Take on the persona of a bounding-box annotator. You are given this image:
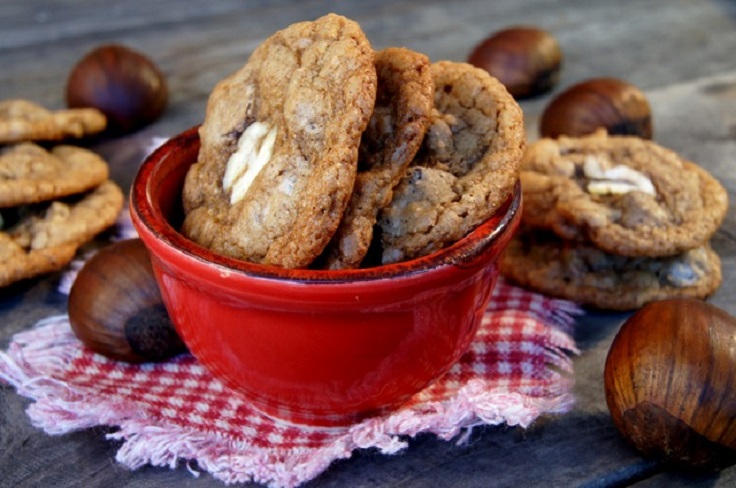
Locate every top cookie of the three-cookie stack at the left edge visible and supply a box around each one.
[0,99,107,144]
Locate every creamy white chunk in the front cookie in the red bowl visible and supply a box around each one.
[222,122,277,204]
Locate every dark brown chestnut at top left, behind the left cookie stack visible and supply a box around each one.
[66,44,169,134]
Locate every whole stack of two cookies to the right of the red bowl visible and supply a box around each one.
[500,131,728,310]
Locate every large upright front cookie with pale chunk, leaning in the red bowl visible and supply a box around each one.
[182,14,376,268]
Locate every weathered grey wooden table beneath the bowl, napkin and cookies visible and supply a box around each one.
[0,0,736,488]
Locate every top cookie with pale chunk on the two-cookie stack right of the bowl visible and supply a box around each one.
[521,131,728,257]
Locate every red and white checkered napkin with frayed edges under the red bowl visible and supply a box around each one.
[0,282,579,486]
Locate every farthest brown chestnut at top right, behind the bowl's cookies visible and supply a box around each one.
[468,26,562,99]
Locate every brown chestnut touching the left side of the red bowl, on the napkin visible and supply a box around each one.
[68,239,186,363]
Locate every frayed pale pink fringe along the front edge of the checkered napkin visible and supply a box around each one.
[0,316,573,488]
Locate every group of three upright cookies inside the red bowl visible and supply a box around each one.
[182,14,526,269]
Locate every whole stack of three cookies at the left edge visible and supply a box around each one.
[0,100,124,286]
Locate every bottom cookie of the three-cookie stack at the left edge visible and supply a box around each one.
[0,181,123,286]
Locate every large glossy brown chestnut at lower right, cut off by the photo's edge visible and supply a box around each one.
[604,298,736,469]
